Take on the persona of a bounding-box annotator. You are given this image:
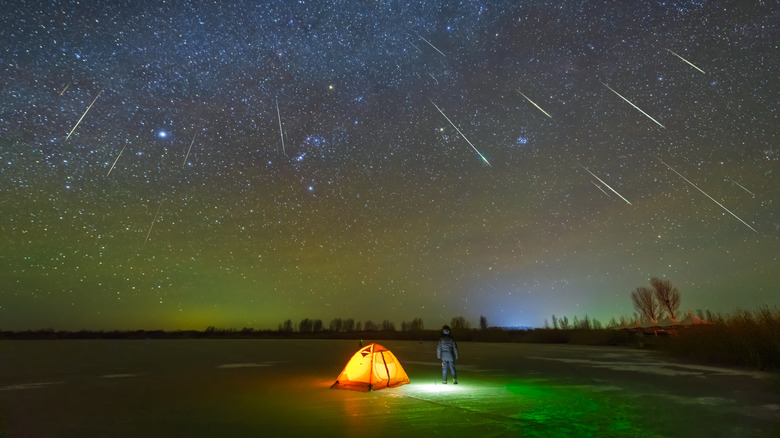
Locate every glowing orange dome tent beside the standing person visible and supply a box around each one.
[330,344,409,391]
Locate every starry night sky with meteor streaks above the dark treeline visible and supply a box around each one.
[0,0,780,330]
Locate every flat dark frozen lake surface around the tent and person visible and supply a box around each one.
[0,340,780,438]
